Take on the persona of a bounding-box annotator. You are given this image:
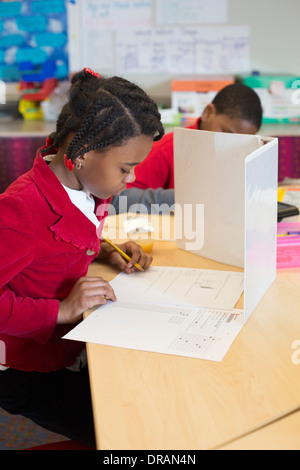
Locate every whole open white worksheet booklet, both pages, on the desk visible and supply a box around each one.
[64,267,243,362]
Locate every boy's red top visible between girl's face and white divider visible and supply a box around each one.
[127,118,201,189]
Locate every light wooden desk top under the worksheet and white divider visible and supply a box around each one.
[87,229,300,450]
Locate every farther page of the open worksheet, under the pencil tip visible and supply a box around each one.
[110,266,244,309]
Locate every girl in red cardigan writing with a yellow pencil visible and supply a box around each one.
[0,69,163,446]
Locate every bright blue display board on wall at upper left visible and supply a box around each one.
[0,0,69,82]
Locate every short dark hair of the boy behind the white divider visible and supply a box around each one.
[212,83,263,129]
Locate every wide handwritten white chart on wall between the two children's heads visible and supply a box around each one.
[116,26,250,75]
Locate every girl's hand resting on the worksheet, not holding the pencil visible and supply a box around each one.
[57,277,117,324]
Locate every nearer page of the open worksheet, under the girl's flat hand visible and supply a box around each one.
[65,301,243,362]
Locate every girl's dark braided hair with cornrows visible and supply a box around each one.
[45,70,164,161]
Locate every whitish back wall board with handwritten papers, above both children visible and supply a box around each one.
[67,0,300,98]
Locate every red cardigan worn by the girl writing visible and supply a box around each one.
[0,152,108,373]
